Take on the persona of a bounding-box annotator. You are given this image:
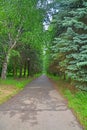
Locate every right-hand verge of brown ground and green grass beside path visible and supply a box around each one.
[49,76,87,130]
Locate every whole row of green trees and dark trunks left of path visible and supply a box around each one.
[0,0,47,79]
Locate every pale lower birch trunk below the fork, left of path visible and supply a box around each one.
[1,54,9,79]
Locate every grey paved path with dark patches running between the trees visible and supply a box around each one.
[0,76,82,130]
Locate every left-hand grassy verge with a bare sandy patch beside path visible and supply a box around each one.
[0,74,40,104]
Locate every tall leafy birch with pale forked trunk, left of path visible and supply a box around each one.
[0,0,43,79]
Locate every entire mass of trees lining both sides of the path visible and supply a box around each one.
[0,0,87,90]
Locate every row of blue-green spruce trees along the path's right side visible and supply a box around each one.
[48,0,87,90]
